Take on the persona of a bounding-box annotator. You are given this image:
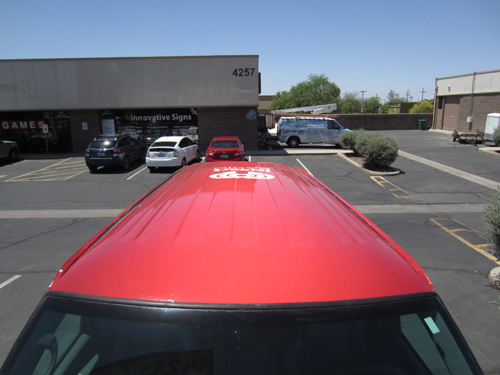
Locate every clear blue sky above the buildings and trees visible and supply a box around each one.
[0,0,500,102]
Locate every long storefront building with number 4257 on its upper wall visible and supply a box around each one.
[0,55,260,153]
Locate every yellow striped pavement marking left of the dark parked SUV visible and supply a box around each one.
[4,158,87,182]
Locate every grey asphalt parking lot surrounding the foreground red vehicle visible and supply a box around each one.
[0,130,500,374]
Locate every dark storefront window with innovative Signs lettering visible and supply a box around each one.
[100,108,198,145]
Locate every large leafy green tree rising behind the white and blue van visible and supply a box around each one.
[269,74,340,111]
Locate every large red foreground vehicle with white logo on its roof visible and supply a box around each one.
[0,162,482,375]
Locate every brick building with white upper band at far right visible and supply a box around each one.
[433,70,500,133]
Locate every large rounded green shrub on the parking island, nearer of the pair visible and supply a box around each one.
[356,133,399,167]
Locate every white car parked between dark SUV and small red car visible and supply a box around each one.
[146,136,201,171]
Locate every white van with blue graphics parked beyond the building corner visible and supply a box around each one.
[278,116,350,147]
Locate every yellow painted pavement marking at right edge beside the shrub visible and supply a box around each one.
[430,218,500,265]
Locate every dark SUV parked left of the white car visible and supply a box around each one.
[85,134,146,172]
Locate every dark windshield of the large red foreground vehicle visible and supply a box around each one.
[0,294,480,375]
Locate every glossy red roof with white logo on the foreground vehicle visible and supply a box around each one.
[50,162,433,304]
